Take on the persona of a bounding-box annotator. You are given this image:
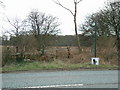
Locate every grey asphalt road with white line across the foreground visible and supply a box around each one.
[2,70,118,88]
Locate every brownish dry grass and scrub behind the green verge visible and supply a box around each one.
[2,38,118,65]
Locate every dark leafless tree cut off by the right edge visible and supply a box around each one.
[102,0,120,61]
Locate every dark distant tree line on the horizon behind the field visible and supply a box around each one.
[1,35,93,46]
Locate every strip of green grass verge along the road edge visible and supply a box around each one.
[2,61,118,72]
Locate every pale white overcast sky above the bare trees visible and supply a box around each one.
[0,0,107,35]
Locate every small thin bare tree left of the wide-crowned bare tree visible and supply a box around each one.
[7,18,25,62]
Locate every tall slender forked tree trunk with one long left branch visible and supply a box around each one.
[54,0,82,52]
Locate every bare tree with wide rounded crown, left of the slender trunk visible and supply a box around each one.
[28,10,60,55]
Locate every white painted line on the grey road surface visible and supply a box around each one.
[24,84,83,88]
